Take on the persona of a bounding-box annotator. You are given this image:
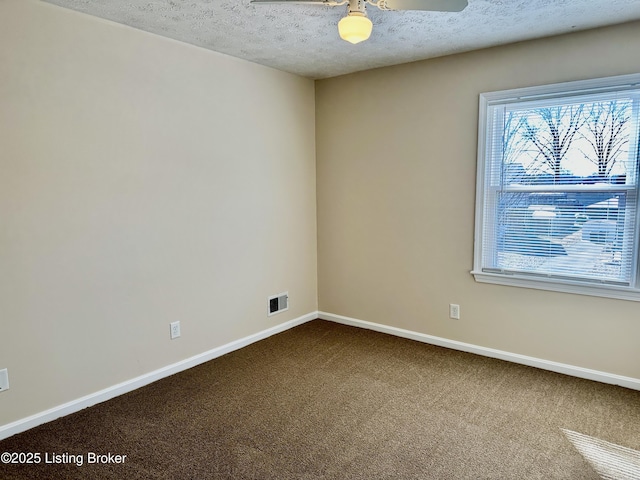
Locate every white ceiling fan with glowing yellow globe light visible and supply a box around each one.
[251,0,468,43]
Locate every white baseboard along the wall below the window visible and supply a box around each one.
[318,312,640,390]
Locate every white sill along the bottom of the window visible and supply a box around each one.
[471,270,640,302]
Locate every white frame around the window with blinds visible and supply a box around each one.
[471,74,640,301]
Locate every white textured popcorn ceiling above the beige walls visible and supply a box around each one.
[46,0,640,78]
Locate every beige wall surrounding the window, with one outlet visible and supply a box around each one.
[316,23,640,378]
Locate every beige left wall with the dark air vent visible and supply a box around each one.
[0,0,317,426]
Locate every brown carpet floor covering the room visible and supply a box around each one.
[0,320,640,480]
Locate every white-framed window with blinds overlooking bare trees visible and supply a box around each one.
[472,74,640,301]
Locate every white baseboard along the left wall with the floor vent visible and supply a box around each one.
[0,312,318,440]
